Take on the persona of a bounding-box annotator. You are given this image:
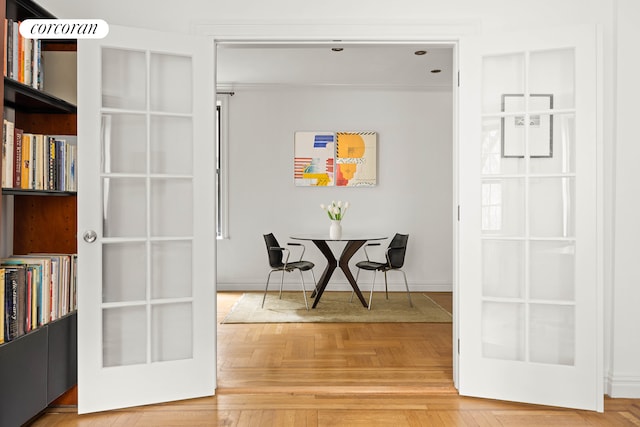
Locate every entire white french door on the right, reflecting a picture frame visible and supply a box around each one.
[458,28,603,411]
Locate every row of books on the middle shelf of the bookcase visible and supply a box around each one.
[2,119,77,191]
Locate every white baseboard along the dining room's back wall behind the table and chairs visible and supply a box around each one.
[217,280,453,292]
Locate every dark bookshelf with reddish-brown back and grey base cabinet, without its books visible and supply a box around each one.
[0,0,77,426]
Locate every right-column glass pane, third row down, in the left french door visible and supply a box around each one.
[151,179,193,237]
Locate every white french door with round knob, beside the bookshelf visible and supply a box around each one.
[78,26,216,413]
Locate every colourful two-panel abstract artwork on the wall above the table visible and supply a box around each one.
[293,131,378,187]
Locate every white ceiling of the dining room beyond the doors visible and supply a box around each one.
[217,43,453,90]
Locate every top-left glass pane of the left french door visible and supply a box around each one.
[102,48,147,110]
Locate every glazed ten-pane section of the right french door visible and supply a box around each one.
[480,49,576,365]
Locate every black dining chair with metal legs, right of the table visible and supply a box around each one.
[351,233,413,310]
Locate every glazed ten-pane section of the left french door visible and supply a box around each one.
[101,48,194,366]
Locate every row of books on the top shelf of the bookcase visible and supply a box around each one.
[4,19,43,90]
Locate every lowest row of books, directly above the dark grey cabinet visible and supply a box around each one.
[0,254,77,343]
